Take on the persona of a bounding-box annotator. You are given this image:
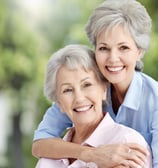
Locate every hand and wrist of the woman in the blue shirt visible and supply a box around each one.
[81,143,148,168]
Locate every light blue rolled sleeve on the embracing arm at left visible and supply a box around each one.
[33,103,72,141]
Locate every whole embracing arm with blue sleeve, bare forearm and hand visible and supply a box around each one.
[32,104,146,168]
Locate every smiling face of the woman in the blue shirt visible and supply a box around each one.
[96,26,142,87]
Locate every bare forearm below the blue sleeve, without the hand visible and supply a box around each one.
[32,138,92,160]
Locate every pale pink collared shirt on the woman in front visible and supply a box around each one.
[36,113,152,168]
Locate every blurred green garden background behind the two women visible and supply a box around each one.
[0,0,158,168]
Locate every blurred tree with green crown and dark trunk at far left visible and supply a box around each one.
[0,0,41,168]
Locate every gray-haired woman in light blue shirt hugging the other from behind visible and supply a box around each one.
[33,0,158,168]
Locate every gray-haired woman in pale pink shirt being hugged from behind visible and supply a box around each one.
[36,44,152,168]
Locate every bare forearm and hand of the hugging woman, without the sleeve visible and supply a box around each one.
[32,138,147,168]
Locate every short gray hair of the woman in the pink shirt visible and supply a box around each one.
[44,44,105,101]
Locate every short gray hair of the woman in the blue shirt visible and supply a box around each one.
[85,0,151,53]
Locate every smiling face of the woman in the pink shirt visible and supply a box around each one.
[57,67,105,124]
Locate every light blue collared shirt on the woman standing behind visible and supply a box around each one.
[34,72,158,168]
